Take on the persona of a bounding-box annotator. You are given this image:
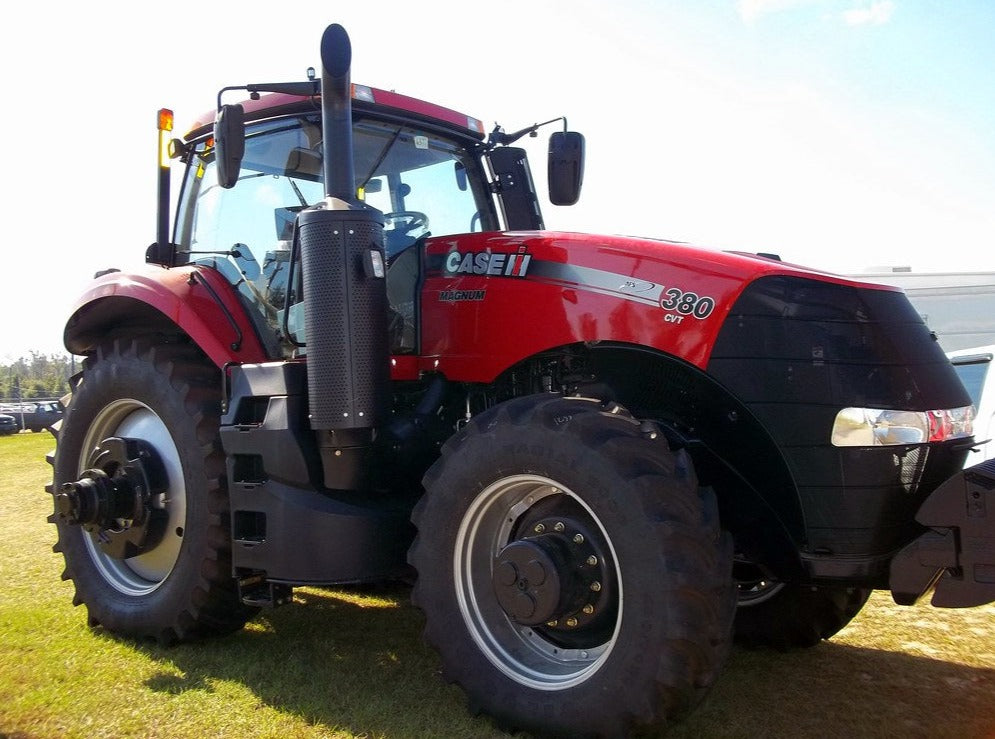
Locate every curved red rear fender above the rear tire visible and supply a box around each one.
[63,265,267,367]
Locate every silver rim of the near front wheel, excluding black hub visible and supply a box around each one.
[453,475,623,691]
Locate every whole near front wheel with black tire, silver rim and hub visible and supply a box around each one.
[409,395,735,736]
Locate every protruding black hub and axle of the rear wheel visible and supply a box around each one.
[55,437,168,559]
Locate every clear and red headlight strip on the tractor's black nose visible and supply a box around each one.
[832,405,974,446]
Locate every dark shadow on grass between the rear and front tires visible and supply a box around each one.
[138,585,507,738]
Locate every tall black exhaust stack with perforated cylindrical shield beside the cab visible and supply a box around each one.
[297,24,390,490]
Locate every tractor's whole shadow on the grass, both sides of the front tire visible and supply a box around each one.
[122,587,995,739]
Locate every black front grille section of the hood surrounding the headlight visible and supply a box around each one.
[707,276,970,568]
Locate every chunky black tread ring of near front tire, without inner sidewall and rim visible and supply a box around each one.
[408,395,735,736]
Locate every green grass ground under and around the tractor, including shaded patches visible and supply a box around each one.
[0,433,995,739]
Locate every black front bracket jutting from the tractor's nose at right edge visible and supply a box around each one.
[889,460,995,608]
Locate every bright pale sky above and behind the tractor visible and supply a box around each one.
[0,0,995,359]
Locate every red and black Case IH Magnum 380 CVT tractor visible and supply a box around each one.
[50,25,995,735]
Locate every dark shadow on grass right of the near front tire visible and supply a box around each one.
[668,641,995,739]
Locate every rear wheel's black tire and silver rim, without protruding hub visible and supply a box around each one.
[50,342,254,643]
